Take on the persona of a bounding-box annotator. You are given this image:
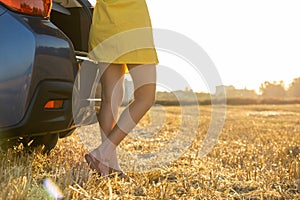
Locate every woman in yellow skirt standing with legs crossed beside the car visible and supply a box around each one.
[85,0,158,178]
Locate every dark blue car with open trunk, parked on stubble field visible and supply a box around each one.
[0,0,92,152]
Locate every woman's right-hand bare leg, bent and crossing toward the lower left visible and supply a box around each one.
[91,64,156,173]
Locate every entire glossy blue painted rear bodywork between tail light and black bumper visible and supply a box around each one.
[0,6,78,134]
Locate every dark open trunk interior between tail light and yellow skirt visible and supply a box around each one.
[50,0,93,52]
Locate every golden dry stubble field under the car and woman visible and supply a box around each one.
[0,104,300,199]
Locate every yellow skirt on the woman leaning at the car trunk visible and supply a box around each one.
[89,0,158,64]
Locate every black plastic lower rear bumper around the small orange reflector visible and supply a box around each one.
[0,80,75,139]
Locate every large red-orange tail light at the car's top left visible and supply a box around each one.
[0,0,52,17]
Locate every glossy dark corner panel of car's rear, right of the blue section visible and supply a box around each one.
[27,16,78,111]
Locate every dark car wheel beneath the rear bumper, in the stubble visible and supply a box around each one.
[24,134,58,154]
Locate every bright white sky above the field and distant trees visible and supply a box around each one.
[88,0,300,91]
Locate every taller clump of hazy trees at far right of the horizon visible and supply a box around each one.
[259,77,300,98]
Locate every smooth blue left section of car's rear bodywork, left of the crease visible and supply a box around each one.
[0,9,35,127]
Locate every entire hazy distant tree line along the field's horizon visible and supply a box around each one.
[156,77,300,105]
